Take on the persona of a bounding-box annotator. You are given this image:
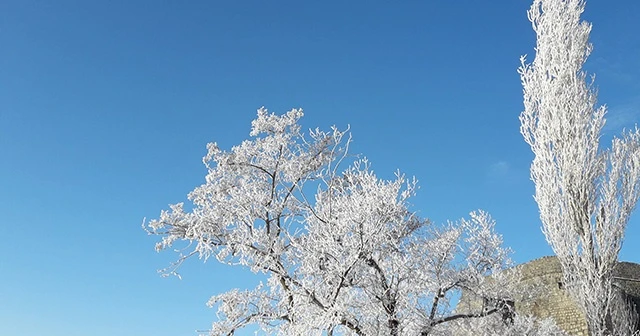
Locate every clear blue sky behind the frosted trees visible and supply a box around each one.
[0,0,640,336]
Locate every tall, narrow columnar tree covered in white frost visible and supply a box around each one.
[519,0,640,335]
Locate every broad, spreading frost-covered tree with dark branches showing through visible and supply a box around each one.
[145,108,510,335]
